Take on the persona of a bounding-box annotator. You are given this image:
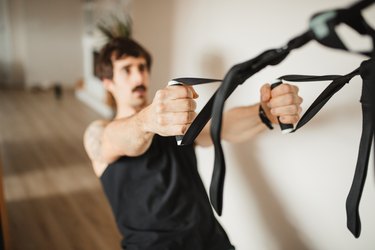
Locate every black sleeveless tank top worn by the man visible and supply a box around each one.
[101,135,234,250]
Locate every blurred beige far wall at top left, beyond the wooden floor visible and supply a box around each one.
[8,0,83,87]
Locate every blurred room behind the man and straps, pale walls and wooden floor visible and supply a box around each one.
[0,0,375,250]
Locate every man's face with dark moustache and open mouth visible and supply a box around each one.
[112,56,149,109]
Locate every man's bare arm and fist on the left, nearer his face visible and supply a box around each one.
[86,86,197,171]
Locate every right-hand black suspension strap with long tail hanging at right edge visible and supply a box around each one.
[279,58,375,238]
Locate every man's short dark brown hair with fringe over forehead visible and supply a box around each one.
[96,37,152,80]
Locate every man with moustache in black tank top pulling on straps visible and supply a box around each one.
[84,38,302,250]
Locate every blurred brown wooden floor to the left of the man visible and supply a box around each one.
[0,90,120,250]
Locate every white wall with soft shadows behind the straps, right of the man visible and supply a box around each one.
[133,0,375,250]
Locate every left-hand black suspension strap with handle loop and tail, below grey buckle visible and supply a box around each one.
[169,31,313,215]
